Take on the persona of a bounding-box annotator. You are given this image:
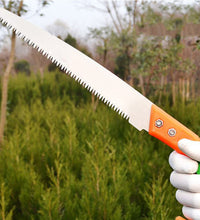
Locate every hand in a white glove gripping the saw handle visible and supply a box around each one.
[169,139,200,220]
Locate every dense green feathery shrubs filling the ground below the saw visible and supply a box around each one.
[0,73,200,220]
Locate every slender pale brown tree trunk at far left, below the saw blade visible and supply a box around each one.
[0,32,16,145]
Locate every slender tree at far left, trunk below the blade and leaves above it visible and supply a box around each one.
[0,0,51,145]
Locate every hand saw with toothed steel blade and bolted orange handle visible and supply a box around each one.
[0,8,200,160]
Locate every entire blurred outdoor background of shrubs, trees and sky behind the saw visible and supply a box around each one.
[0,0,200,220]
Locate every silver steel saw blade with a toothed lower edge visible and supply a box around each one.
[0,8,152,131]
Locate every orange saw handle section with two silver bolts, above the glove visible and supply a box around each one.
[149,105,200,154]
